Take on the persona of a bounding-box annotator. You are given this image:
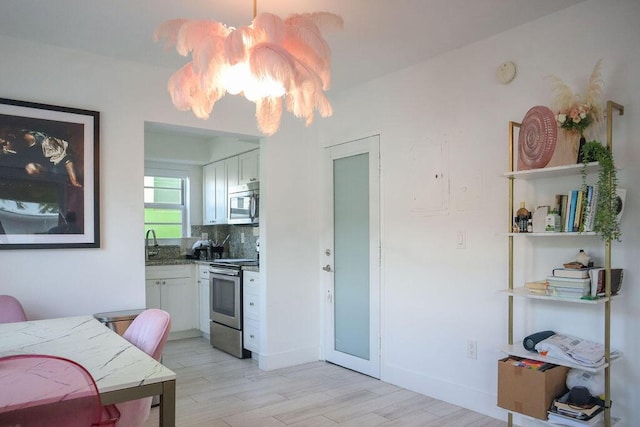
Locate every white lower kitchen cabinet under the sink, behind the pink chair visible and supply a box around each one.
[145,265,199,338]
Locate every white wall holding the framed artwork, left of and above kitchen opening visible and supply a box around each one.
[0,37,256,319]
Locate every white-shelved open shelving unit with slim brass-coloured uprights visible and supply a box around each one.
[501,101,624,427]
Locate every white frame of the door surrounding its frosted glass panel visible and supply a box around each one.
[319,133,382,378]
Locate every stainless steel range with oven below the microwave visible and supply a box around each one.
[209,258,258,359]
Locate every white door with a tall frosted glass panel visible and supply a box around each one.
[322,135,380,378]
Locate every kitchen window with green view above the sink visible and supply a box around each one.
[144,176,188,239]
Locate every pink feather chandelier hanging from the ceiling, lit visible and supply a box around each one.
[154,0,343,135]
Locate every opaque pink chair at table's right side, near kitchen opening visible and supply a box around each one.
[116,308,171,427]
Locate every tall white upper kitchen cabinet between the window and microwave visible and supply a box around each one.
[202,160,227,225]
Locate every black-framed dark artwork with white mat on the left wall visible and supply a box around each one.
[0,98,100,249]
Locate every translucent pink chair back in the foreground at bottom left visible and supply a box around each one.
[0,354,119,427]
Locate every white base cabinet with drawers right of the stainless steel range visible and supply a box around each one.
[242,271,260,353]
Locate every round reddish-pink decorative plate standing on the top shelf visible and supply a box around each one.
[518,105,558,170]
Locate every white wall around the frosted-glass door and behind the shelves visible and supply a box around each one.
[261,0,640,425]
